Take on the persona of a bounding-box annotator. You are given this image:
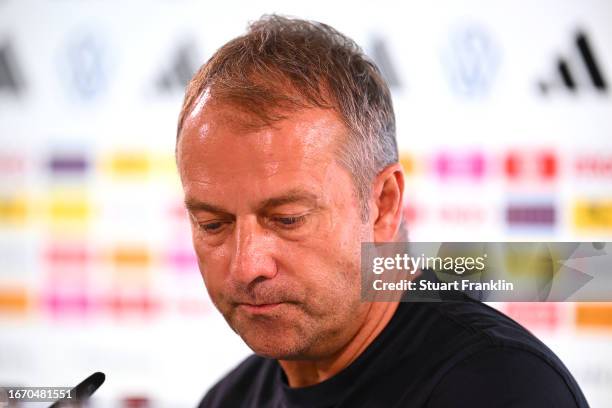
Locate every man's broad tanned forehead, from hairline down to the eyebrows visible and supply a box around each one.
[177,105,346,204]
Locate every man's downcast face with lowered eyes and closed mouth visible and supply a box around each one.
[177,105,372,359]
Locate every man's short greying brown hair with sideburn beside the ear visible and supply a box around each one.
[177,15,398,222]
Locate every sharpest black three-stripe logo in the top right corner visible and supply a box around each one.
[538,31,608,95]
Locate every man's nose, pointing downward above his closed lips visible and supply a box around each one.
[230,217,277,285]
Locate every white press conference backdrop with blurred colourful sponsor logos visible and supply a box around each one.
[0,0,612,407]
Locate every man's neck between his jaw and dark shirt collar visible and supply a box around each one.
[279,302,399,387]
